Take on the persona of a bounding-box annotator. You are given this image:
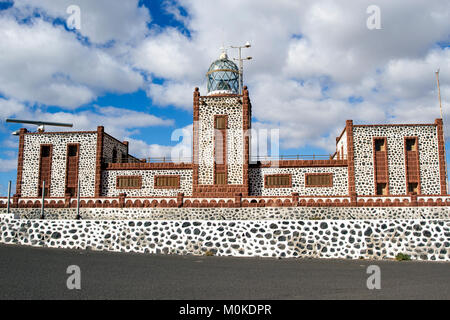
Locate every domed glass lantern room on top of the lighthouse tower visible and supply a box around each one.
[206,52,239,95]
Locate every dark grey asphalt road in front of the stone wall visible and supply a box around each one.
[0,245,450,300]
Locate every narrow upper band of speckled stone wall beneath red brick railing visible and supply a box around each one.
[0,207,450,220]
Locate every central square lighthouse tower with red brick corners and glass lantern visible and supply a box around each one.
[192,51,251,198]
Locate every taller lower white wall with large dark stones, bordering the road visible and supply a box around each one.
[0,215,450,261]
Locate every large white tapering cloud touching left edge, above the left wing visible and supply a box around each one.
[0,14,143,108]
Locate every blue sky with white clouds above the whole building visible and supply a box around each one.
[0,0,450,195]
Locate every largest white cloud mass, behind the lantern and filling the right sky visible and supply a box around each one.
[134,0,450,152]
